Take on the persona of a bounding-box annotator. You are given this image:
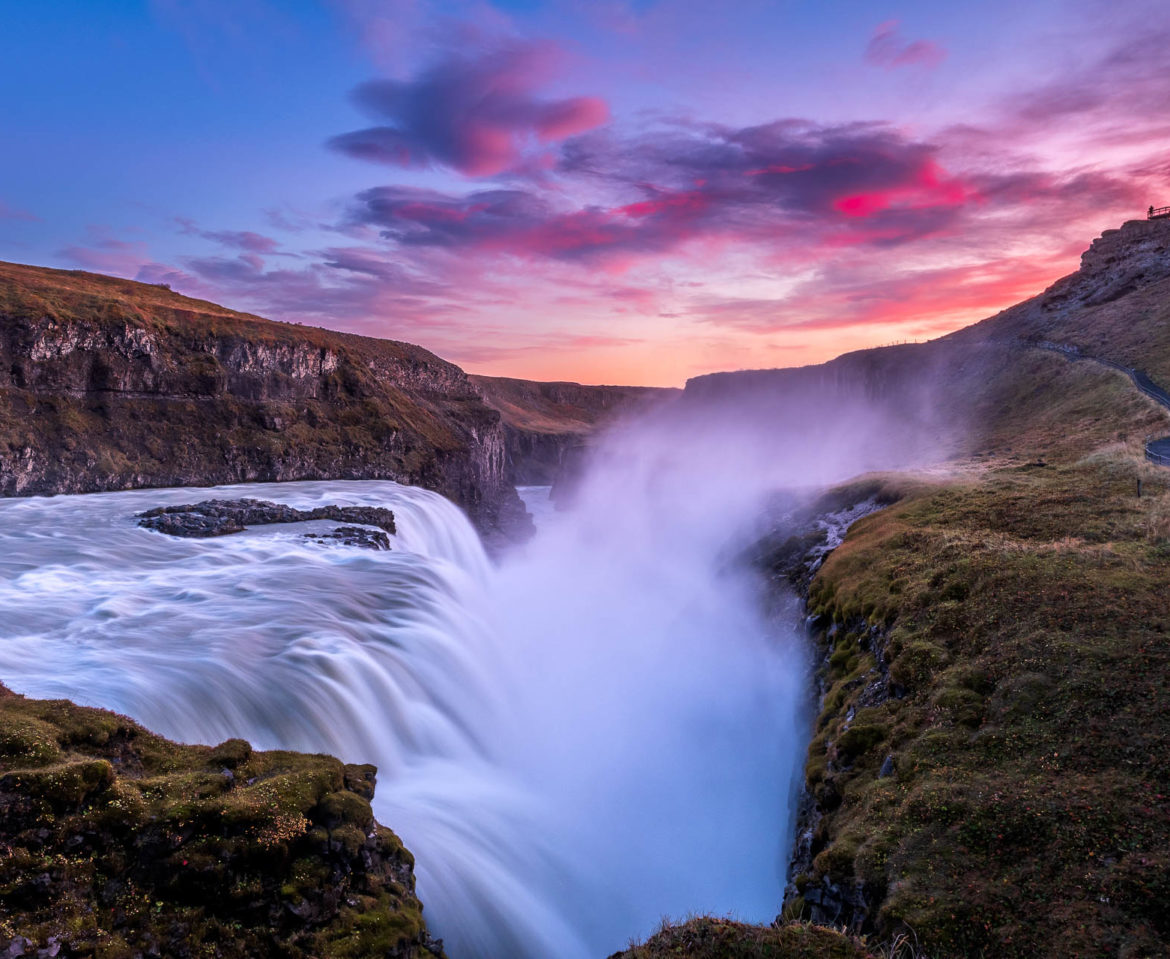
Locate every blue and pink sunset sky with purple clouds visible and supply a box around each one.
[0,0,1170,386]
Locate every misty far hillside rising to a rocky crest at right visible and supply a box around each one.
[683,220,1170,462]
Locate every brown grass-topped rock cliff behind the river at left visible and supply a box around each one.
[0,263,523,532]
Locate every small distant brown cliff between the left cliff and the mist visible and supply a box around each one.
[470,375,679,485]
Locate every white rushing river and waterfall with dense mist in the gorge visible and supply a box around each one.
[0,416,833,959]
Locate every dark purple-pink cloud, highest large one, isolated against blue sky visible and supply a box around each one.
[329,43,608,177]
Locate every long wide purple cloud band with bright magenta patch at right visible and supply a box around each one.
[341,120,977,265]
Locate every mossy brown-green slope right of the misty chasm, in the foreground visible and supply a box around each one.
[806,448,1170,959]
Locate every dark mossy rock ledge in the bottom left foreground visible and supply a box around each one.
[0,687,443,959]
